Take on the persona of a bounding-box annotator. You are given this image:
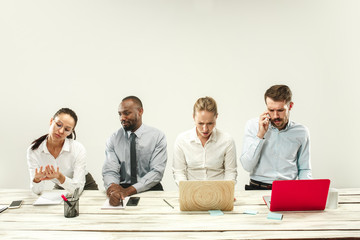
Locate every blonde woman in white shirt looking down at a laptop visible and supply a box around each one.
[173,97,237,184]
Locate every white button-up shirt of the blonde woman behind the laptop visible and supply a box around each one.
[173,127,237,184]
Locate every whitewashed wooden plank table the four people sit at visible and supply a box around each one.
[0,189,360,240]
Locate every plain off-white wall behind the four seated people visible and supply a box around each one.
[0,0,360,190]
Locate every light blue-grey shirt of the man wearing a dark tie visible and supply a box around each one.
[102,124,167,193]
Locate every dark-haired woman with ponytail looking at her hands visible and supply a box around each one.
[27,108,98,194]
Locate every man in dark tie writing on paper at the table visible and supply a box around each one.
[102,96,167,206]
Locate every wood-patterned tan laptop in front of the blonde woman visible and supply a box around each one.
[179,180,235,211]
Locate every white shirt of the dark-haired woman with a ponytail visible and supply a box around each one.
[27,138,87,194]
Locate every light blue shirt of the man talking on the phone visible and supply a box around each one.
[240,118,312,184]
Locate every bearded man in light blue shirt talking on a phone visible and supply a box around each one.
[240,85,311,190]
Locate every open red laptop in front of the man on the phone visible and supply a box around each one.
[263,179,330,212]
